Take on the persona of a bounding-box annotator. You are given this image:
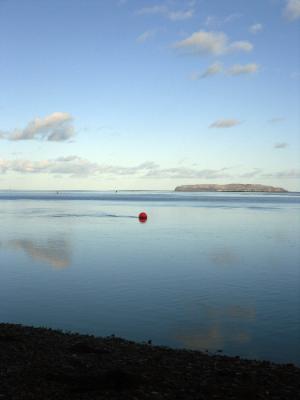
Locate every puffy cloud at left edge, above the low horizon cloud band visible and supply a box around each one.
[0,112,75,142]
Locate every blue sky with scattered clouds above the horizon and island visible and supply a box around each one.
[0,0,300,191]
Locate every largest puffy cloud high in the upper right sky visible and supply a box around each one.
[174,30,253,56]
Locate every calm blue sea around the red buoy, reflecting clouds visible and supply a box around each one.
[0,191,300,365]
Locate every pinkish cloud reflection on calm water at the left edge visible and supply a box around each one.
[8,238,71,269]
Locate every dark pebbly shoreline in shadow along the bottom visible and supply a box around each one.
[0,323,300,400]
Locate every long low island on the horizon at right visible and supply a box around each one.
[175,183,288,193]
